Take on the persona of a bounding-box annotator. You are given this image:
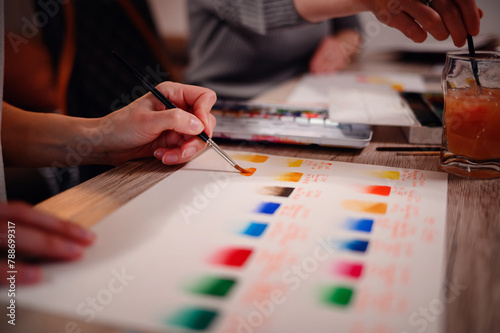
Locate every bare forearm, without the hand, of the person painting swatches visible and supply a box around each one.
[1,103,105,167]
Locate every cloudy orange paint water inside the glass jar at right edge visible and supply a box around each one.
[444,87,500,160]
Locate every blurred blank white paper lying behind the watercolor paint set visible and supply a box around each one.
[288,72,425,126]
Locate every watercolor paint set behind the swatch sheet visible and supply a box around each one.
[212,101,373,149]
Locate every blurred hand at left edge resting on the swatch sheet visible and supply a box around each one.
[0,202,95,285]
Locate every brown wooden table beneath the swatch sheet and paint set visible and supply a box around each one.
[14,53,500,333]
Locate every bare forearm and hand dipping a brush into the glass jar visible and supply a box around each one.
[293,0,481,47]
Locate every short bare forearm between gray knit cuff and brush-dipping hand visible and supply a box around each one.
[293,0,368,23]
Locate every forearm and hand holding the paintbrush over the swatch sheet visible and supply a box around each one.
[1,82,216,167]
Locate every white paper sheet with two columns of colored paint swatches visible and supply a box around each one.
[13,150,447,333]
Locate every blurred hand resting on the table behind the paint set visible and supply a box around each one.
[309,29,361,74]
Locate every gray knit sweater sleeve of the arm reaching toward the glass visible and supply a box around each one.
[196,0,307,35]
